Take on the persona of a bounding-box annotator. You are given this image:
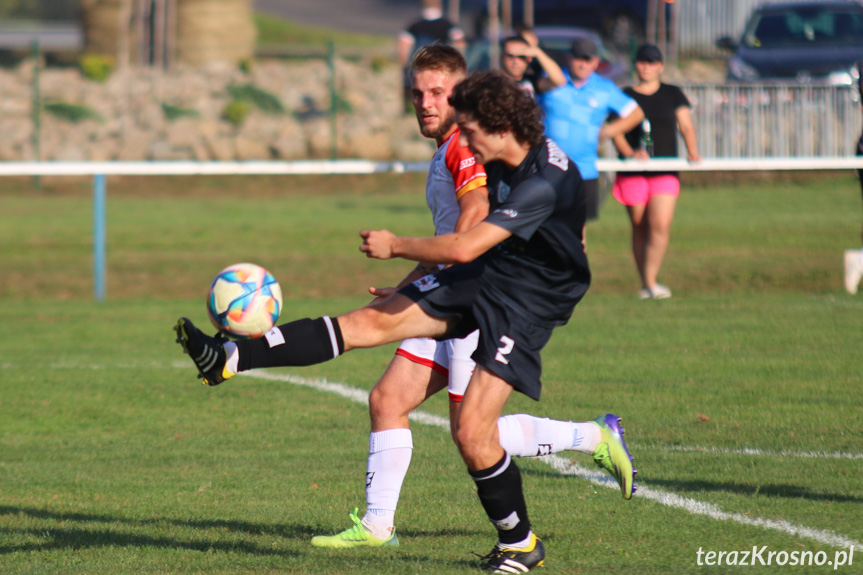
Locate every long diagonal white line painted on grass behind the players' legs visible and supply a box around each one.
[242,370,863,549]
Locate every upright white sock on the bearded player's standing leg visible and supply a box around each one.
[363,429,414,539]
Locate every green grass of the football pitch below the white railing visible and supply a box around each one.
[0,174,863,575]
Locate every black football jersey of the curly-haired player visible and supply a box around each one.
[483,139,590,326]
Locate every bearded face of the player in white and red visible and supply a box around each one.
[411,70,461,141]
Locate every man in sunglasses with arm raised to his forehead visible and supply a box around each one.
[500,34,566,96]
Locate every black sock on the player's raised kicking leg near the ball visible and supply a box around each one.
[237,316,345,371]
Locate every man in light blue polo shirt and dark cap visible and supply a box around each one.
[539,38,644,220]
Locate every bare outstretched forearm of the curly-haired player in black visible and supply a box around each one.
[360,222,512,264]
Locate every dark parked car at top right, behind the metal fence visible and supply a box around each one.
[717,0,863,85]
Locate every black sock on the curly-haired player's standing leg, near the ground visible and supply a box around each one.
[469,453,530,543]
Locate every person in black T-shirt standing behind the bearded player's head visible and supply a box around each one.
[398,0,466,111]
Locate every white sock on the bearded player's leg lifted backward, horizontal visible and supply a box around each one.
[497,413,601,457]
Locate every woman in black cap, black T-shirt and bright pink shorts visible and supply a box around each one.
[612,44,701,299]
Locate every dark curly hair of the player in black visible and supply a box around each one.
[450,71,545,147]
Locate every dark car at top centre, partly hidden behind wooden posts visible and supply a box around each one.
[459,0,648,48]
